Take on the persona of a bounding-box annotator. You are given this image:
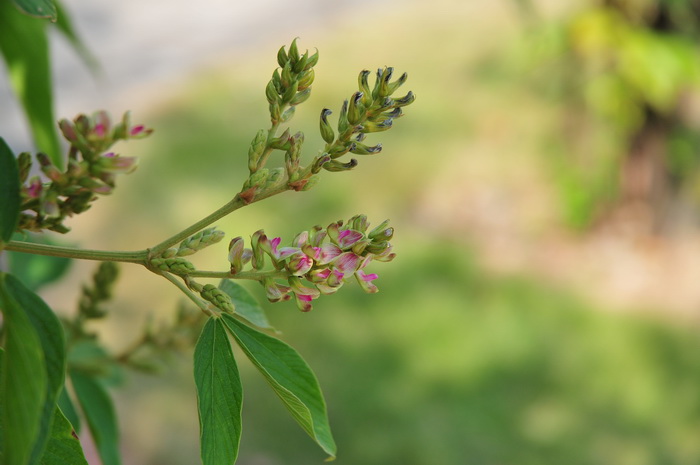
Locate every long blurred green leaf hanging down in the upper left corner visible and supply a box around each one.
[0,1,63,168]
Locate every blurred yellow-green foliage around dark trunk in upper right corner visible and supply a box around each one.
[519,0,700,227]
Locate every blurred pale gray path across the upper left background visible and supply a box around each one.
[0,0,393,152]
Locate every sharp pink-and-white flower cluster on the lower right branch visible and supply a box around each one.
[229,215,395,312]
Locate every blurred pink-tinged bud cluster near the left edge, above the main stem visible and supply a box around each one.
[17,112,152,233]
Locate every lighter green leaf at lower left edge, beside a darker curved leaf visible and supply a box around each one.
[0,274,48,465]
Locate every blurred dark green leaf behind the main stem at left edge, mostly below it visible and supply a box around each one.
[5,234,72,291]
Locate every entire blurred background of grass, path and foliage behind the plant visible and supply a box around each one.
[6,0,700,465]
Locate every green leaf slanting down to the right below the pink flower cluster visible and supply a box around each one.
[222,314,336,458]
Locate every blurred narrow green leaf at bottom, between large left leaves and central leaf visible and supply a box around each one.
[70,370,121,465]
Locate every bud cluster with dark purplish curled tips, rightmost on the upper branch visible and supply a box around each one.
[317,67,415,171]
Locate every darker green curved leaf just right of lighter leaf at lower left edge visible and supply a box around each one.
[5,275,66,463]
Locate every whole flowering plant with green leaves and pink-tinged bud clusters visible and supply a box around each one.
[0,36,414,465]
